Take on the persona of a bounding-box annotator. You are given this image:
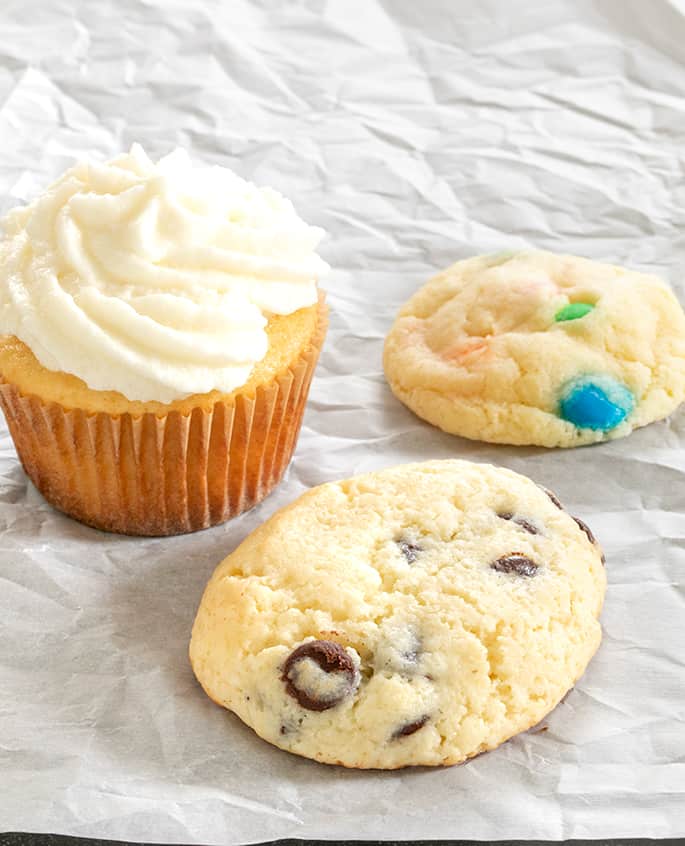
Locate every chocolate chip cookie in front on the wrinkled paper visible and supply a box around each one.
[190,460,606,769]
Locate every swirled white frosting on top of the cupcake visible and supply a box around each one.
[0,144,328,402]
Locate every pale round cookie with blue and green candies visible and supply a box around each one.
[384,251,685,447]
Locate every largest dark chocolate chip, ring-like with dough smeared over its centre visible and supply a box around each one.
[281,640,359,711]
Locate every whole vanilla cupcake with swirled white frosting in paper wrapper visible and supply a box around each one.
[0,145,328,535]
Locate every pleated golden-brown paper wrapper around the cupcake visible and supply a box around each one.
[0,299,327,536]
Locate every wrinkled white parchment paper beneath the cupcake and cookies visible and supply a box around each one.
[0,0,685,844]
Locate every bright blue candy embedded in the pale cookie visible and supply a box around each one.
[559,375,635,432]
